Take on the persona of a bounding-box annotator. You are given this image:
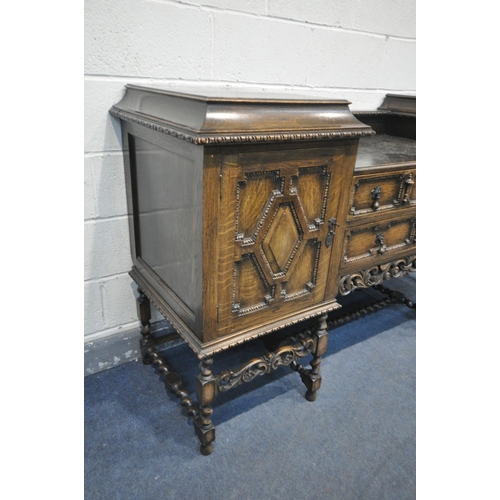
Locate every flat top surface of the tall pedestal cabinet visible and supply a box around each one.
[126,84,351,104]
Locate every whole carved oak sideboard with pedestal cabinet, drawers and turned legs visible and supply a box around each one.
[110,85,415,455]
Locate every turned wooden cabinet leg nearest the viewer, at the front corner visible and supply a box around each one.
[194,358,216,455]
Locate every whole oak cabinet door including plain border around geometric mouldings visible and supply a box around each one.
[215,146,348,335]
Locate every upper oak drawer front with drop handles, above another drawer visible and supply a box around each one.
[348,169,416,220]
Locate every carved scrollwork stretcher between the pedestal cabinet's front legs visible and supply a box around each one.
[216,331,314,392]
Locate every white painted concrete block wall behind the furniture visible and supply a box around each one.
[84,0,416,372]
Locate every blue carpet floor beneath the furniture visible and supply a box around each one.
[85,274,416,500]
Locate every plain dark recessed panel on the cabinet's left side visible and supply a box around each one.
[128,135,200,323]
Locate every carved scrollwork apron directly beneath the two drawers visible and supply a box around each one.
[339,255,417,295]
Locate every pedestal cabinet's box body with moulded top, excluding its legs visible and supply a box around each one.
[111,85,373,357]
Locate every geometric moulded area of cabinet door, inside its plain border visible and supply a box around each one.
[232,165,331,316]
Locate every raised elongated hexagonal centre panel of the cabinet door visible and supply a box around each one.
[262,202,303,275]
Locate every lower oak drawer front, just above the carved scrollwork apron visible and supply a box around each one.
[341,215,416,269]
